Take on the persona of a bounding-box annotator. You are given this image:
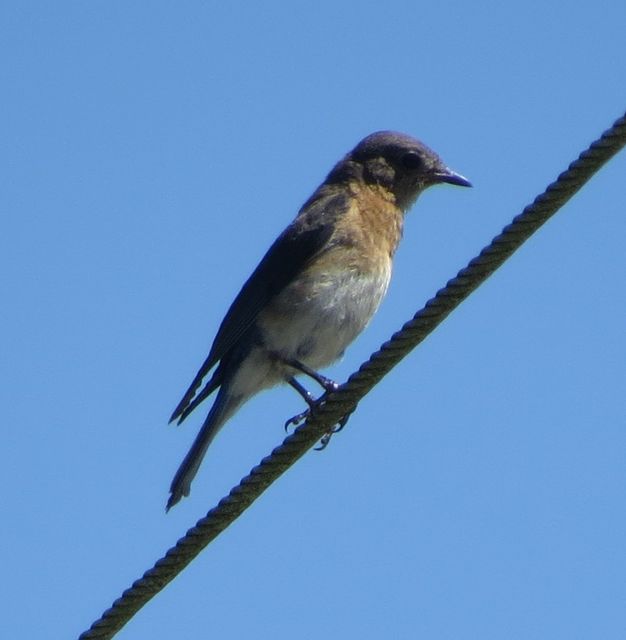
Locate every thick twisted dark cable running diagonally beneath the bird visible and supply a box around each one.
[80,110,626,640]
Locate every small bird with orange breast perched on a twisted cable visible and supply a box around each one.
[166,131,472,510]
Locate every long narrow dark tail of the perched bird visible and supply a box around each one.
[165,385,245,511]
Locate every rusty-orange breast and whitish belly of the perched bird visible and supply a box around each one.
[257,185,403,376]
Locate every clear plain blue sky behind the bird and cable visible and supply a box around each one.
[0,0,626,640]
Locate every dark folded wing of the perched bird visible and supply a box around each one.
[170,194,349,422]
